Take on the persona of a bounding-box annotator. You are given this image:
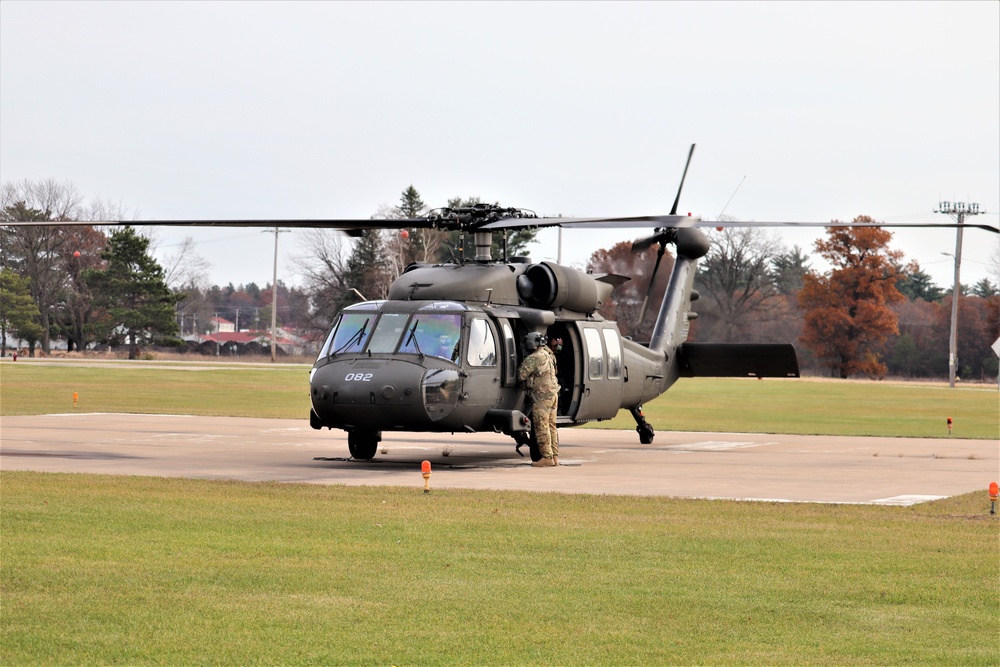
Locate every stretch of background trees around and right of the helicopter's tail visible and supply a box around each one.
[587,216,1000,380]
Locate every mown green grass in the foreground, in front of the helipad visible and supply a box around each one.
[0,472,1000,665]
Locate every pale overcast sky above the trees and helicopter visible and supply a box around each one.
[0,0,1000,287]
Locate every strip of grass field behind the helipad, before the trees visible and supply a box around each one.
[0,362,1000,439]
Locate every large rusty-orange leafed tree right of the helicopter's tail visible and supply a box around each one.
[799,215,905,378]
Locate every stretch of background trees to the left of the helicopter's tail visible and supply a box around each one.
[0,180,535,358]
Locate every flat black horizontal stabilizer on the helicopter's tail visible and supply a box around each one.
[678,343,799,378]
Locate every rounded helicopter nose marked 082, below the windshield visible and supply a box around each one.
[310,359,459,430]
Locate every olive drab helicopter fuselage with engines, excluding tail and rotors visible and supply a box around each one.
[310,263,680,438]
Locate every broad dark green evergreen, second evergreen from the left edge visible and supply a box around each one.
[85,227,184,359]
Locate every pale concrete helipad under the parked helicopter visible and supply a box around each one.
[0,414,1000,505]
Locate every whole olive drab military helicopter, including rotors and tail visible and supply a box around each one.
[7,145,998,460]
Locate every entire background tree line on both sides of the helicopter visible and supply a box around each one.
[0,181,1000,379]
